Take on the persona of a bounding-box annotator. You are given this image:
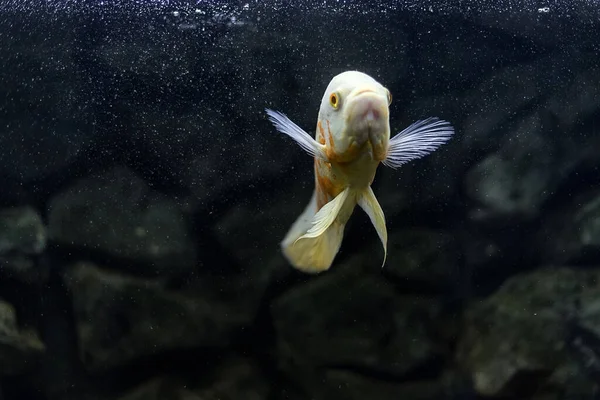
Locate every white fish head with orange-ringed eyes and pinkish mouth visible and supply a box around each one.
[318,71,392,162]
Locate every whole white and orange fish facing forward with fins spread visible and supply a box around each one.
[266,71,454,273]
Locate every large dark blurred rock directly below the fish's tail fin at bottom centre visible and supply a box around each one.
[272,258,443,377]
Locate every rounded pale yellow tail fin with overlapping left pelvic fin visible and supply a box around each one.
[281,189,349,274]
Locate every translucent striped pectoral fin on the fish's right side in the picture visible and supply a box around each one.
[382,117,454,169]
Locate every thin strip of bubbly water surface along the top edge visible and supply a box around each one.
[0,0,598,18]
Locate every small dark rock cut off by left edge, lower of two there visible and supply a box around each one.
[0,301,45,375]
